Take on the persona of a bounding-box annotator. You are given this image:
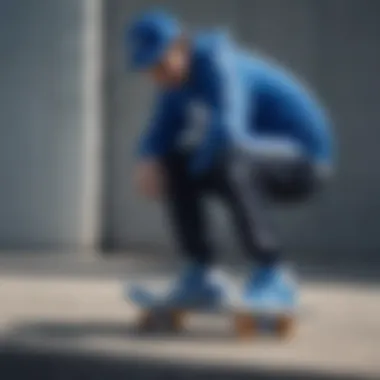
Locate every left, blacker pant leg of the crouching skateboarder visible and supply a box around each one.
[163,153,212,264]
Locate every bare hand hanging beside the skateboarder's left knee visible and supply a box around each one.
[135,159,164,199]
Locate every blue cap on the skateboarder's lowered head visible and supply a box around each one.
[125,11,181,70]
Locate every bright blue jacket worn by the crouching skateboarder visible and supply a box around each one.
[138,33,332,173]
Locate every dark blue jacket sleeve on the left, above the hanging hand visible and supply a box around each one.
[137,93,183,158]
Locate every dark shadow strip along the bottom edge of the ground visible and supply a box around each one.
[0,347,374,380]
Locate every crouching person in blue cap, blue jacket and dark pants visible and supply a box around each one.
[126,11,333,307]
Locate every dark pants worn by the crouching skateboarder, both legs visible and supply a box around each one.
[164,148,318,264]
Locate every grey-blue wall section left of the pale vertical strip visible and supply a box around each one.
[0,0,93,249]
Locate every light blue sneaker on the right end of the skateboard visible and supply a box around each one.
[243,266,297,311]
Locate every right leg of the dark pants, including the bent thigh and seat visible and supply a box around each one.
[206,139,328,265]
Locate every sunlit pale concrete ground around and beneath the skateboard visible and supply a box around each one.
[0,254,380,379]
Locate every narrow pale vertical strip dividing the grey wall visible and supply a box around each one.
[80,0,103,249]
